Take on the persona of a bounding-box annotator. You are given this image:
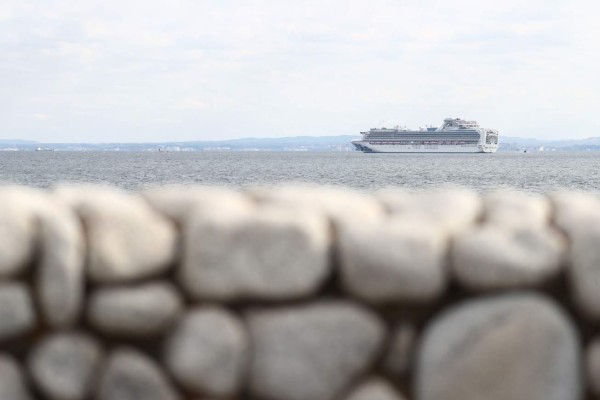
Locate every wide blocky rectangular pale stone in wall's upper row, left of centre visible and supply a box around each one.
[179,203,330,300]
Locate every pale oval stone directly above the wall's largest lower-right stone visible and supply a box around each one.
[451,225,566,290]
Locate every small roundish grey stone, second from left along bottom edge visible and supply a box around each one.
[29,333,102,400]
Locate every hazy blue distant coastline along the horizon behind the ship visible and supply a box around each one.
[0,135,600,152]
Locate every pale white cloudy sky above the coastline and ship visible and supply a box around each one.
[0,0,600,142]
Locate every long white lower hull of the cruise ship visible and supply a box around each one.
[352,140,498,153]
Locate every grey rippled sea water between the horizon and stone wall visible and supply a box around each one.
[0,152,600,192]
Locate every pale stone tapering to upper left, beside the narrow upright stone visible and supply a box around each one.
[56,187,177,284]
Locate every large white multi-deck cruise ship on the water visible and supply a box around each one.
[352,118,498,153]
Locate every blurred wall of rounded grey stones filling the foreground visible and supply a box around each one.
[0,186,600,400]
